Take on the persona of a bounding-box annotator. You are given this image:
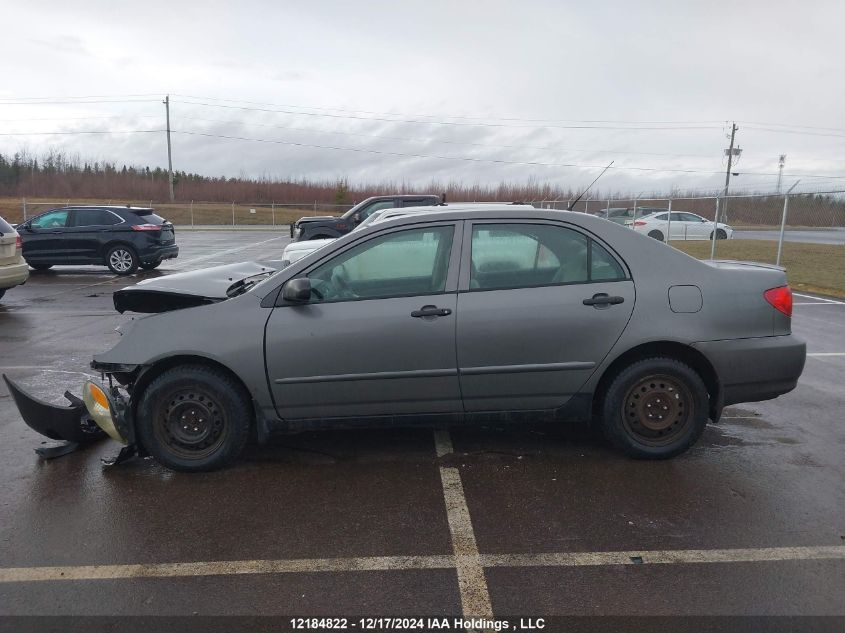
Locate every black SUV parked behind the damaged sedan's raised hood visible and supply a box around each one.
[17,206,179,275]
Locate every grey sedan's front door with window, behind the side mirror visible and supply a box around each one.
[265,223,461,419]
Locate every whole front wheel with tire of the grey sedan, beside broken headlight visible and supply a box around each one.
[137,365,252,472]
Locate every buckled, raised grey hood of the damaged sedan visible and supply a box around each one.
[114,262,280,313]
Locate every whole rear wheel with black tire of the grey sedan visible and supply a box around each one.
[601,357,708,459]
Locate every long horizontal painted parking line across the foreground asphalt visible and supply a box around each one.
[0,545,845,584]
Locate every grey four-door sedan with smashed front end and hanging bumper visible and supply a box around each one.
[1,206,806,471]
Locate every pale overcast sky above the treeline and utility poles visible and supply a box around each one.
[0,0,845,192]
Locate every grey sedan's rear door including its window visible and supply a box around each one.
[457,221,635,411]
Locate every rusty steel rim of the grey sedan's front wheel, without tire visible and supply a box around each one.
[153,388,229,459]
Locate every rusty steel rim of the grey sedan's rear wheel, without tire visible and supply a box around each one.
[622,374,695,446]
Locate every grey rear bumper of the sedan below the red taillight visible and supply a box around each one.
[695,334,807,405]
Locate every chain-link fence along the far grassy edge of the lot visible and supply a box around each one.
[6,191,845,264]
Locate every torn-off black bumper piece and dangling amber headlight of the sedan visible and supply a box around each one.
[3,374,137,464]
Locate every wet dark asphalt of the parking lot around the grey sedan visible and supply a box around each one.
[0,228,845,616]
